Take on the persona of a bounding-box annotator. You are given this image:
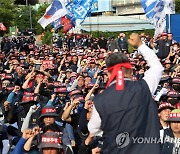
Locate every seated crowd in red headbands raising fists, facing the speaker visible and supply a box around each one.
[0,33,180,154]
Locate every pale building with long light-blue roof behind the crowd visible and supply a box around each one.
[82,0,153,32]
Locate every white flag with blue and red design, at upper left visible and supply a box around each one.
[38,0,67,28]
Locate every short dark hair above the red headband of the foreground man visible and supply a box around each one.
[106,52,129,67]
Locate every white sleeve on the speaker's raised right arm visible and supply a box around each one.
[138,44,164,94]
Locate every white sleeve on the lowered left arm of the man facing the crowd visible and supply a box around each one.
[88,106,103,136]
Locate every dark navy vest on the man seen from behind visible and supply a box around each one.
[94,80,160,154]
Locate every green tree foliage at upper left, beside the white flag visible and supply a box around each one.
[0,0,51,35]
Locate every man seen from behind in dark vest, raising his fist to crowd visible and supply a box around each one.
[88,33,163,154]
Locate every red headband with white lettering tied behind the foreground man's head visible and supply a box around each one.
[106,62,132,90]
